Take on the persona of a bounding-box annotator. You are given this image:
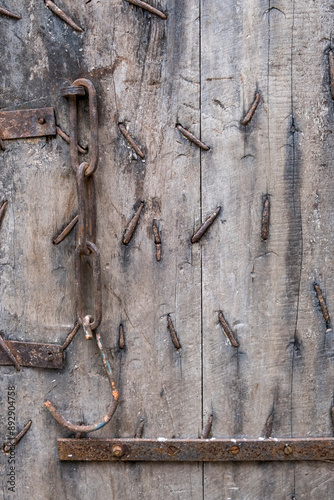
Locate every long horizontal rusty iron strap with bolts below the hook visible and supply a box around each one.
[58,438,334,462]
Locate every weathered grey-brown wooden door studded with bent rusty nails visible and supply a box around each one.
[0,0,334,500]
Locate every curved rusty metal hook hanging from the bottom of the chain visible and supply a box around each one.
[44,331,118,433]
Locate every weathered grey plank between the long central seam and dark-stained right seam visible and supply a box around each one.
[201,0,300,500]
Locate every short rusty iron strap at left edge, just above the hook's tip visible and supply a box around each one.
[0,340,64,370]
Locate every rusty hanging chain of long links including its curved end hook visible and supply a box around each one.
[44,78,118,433]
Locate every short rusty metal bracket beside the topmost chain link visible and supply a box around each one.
[0,108,56,140]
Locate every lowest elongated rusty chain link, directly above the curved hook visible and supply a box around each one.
[75,241,102,330]
